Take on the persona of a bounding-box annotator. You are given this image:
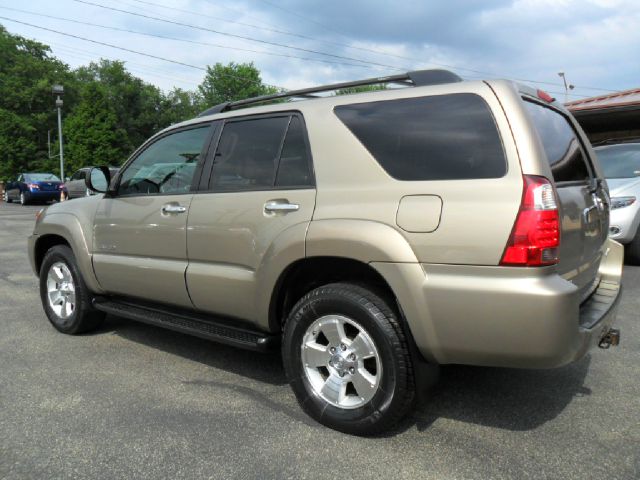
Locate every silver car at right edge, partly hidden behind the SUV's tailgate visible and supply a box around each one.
[595,141,640,265]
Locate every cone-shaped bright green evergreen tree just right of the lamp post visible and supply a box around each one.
[64,82,130,172]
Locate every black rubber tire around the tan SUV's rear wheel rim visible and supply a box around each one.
[282,283,415,435]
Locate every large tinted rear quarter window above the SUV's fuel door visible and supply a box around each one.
[335,93,507,180]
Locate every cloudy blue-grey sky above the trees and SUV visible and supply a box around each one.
[0,0,640,99]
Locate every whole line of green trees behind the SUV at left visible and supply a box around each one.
[0,25,276,181]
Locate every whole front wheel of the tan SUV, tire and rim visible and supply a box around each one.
[40,245,105,335]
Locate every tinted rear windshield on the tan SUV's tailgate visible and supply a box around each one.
[524,101,589,182]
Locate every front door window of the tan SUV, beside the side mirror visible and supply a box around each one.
[118,125,210,195]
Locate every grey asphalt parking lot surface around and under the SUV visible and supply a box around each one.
[0,203,640,479]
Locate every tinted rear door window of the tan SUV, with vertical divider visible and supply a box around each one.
[209,115,313,192]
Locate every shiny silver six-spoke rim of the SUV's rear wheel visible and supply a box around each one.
[301,315,382,409]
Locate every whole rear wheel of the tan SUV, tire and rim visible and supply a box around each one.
[282,283,415,435]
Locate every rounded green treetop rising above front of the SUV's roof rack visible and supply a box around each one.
[198,62,278,108]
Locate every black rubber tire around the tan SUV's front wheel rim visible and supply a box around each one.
[40,245,105,335]
